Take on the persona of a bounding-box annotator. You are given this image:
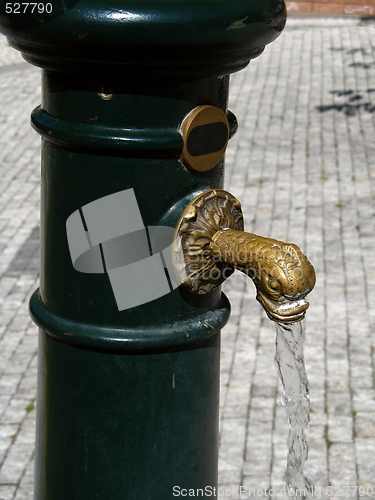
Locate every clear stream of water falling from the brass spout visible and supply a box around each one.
[275,322,314,500]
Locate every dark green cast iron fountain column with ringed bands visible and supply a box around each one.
[0,0,285,500]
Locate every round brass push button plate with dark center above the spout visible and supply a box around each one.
[180,105,230,172]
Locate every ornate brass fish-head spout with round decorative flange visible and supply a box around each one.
[174,189,315,322]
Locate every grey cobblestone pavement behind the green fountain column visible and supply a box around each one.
[0,18,375,500]
